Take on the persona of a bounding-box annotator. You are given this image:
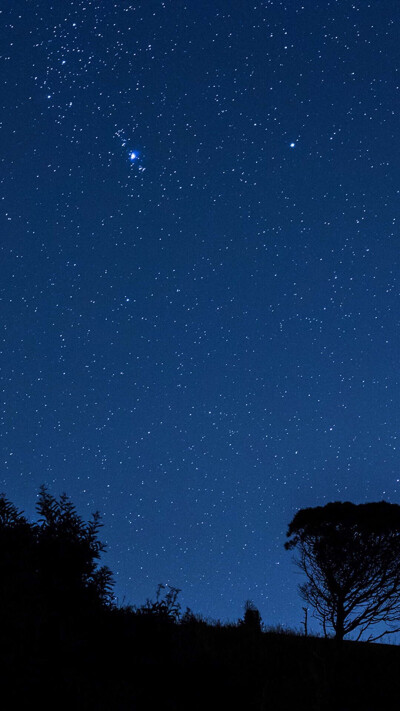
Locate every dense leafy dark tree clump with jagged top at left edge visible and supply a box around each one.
[0,487,113,635]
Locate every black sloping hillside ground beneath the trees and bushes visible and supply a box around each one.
[1,609,400,711]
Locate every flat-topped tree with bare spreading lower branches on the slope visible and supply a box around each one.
[285,501,400,641]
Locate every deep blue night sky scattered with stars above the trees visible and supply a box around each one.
[0,0,400,626]
